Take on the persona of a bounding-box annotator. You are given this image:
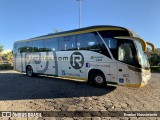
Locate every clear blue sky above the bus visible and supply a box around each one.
[0,0,160,49]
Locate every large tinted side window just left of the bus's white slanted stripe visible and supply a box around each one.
[77,33,101,51]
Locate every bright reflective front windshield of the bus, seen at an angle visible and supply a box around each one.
[135,40,150,69]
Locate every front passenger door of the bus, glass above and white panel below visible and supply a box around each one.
[117,40,135,85]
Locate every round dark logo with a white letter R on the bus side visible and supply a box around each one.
[70,52,84,69]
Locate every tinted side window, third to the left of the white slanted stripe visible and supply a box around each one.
[44,38,58,51]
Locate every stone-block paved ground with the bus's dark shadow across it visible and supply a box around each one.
[0,70,160,120]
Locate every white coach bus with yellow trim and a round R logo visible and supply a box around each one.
[13,25,151,88]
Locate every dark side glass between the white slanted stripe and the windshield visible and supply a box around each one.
[104,38,137,65]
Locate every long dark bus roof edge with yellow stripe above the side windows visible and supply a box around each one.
[15,25,129,43]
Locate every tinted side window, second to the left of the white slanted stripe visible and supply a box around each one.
[59,36,77,51]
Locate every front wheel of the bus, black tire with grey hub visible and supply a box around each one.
[91,72,106,87]
